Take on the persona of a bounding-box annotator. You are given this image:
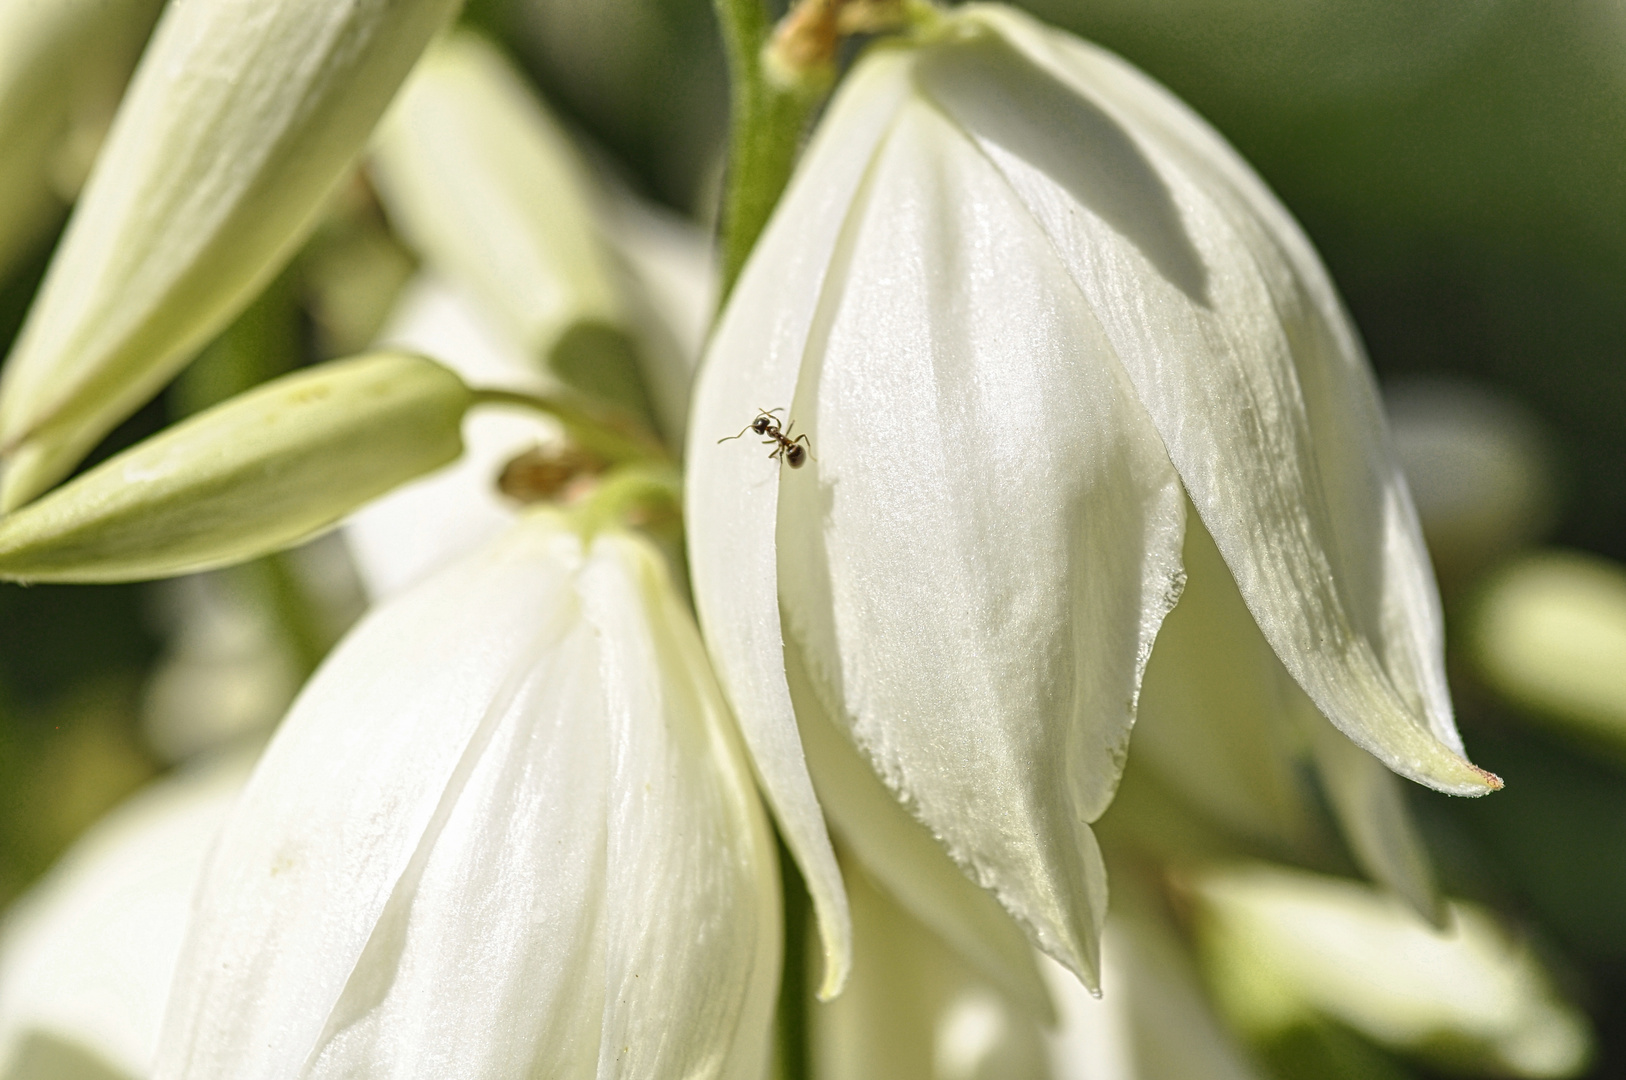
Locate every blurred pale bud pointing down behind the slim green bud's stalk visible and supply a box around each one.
[371,33,686,436]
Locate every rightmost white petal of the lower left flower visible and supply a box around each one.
[580,535,782,1080]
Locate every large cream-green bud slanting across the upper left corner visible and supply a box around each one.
[0,0,457,509]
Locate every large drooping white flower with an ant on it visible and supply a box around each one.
[688,7,1498,991]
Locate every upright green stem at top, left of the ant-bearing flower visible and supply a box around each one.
[712,0,824,301]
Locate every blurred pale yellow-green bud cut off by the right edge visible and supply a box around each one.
[1467,551,1626,758]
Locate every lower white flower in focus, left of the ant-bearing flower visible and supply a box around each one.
[156,514,780,1080]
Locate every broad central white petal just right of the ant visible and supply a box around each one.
[773,97,1184,982]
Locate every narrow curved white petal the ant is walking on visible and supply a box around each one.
[685,48,906,995]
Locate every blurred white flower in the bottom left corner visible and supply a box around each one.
[0,750,255,1080]
